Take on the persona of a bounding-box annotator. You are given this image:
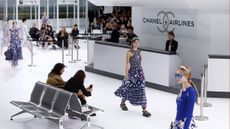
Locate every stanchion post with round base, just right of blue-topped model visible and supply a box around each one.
[194,73,208,121]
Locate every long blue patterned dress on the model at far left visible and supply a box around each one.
[9,28,22,66]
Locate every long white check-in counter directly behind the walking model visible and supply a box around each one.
[92,41,181,87]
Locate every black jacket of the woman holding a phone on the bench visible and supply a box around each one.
[64,78,91,96]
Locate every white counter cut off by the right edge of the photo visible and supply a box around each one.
[208,55,230,96]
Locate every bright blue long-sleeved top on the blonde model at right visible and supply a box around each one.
[172,86,197,129]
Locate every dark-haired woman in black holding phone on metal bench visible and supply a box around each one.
[64,70,93,105]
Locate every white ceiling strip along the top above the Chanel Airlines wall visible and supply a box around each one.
[89,0,229,10]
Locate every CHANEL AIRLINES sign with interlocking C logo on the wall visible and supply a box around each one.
[141,9,197,38]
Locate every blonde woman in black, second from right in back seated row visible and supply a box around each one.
[57,26,69,49]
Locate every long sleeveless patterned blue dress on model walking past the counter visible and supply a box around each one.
[114,50,147,106]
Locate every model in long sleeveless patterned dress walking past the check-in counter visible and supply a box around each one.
[115,38,151,117]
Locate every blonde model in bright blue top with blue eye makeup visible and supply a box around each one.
[171,66,198,129]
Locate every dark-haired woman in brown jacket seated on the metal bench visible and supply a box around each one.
[46,63,66,88]
